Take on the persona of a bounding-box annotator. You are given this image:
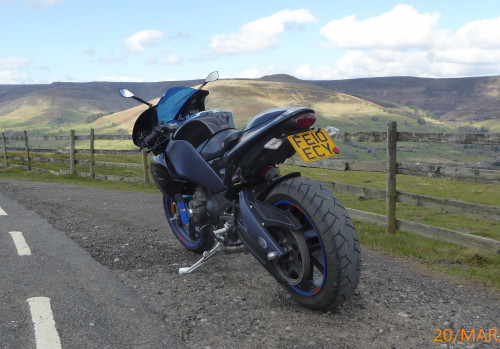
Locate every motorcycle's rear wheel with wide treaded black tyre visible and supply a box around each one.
[266,177,361,309]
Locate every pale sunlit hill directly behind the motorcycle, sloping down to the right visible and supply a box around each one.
[84,79,451,134]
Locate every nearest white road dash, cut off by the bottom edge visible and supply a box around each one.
[28,297,61,349]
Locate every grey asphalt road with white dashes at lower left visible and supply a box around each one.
[0,190,177,348]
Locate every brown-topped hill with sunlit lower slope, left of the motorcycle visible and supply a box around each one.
[0,80,203,131]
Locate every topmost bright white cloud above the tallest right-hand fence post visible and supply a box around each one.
[320,5,439,49]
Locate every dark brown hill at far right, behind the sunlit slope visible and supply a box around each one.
[268,75,500,132]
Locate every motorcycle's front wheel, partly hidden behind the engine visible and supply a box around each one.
[163,195,214,254]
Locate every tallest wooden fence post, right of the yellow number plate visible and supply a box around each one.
[385,121,398,234]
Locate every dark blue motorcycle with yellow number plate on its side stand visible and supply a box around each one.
[120,72,361,309]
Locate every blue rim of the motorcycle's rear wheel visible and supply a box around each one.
[274,200,326,296]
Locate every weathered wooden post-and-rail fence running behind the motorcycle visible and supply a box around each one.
[2,122,500,254]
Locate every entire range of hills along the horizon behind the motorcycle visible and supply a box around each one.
[0,74,500,133]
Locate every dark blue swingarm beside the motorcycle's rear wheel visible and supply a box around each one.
[237,174,302,266]
